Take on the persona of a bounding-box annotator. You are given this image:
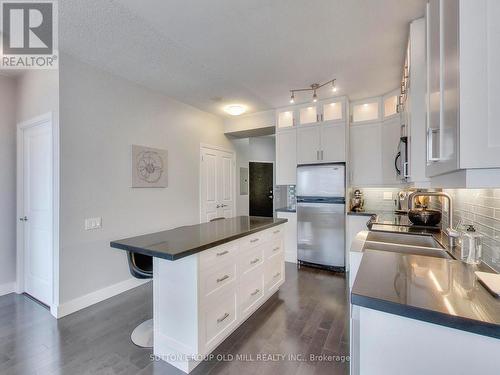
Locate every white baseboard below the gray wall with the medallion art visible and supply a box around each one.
[51,279,151,319]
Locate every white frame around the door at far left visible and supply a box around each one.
[16,112,59,317]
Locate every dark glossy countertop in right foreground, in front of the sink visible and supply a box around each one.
[351,250,500,339]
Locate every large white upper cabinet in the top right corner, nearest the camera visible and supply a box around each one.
[426,0,500,187]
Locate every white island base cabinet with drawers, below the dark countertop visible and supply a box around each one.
[153,224,285,373]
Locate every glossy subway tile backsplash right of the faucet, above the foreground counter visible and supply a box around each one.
[443,189,500,272]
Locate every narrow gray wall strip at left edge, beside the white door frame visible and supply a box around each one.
[0,75,16,294]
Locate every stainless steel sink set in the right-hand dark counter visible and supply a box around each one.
[363,232,453,259]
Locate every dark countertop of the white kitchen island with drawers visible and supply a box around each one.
[110,216,288,260]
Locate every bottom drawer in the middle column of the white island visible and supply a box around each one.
[239,267,264,318]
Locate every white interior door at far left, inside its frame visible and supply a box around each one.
[20,120,53,306]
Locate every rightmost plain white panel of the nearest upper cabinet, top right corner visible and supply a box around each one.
[460,0,500,168]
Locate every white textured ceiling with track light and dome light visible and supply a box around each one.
[59,0,426,115]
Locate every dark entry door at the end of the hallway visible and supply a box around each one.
[249,162,273,217]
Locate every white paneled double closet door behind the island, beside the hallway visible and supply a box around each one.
[200,147,235,222]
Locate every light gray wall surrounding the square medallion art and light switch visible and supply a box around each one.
[60,55,232,303]
